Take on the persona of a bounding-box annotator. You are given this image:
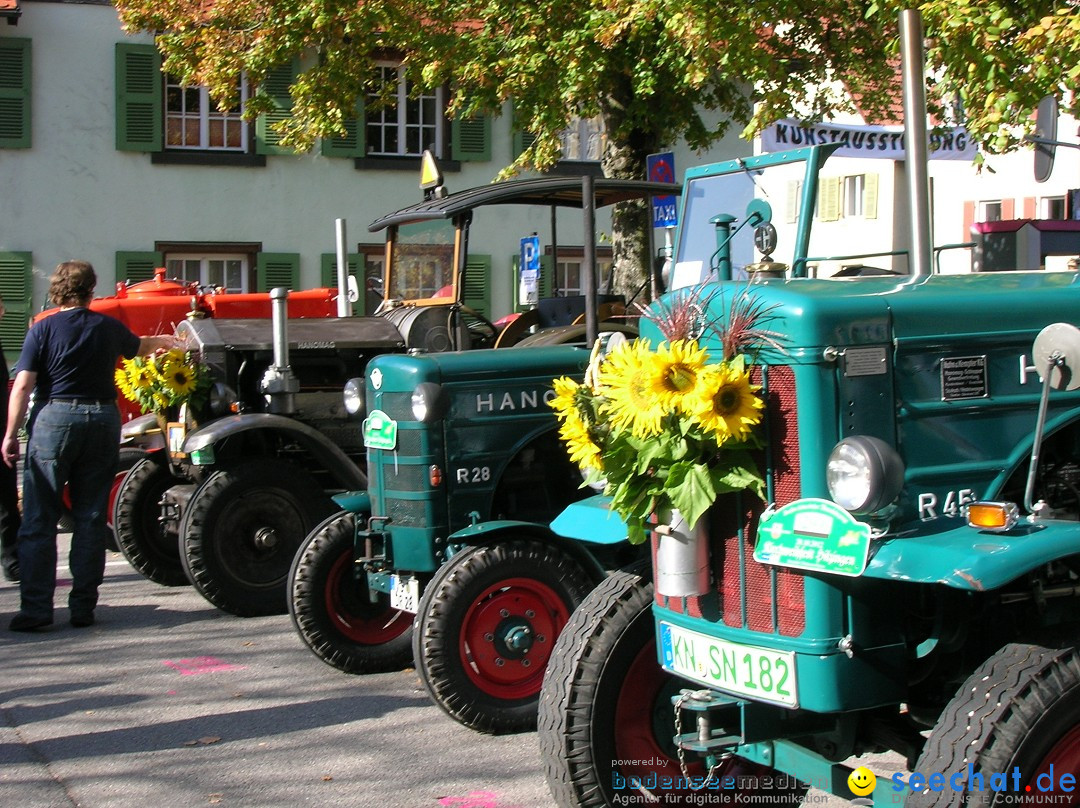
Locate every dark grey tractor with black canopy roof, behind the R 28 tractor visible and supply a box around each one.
[117,170,672,616]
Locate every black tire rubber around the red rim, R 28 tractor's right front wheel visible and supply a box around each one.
[413,539,594,735]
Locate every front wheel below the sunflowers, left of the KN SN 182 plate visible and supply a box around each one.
[539,564,806,808]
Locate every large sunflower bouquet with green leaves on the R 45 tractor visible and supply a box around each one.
[551,287,768,543]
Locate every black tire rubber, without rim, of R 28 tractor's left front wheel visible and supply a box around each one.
[288,513,413,674]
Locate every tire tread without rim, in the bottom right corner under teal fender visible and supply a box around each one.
[905,643,1080,808]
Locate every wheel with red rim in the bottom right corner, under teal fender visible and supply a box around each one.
[904,643,1080,808]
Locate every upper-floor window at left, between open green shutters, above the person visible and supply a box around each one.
[165,75,247,151]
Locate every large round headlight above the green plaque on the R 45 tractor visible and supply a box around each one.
[825,435,904,513]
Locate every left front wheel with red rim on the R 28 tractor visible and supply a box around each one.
[288,513,413,673]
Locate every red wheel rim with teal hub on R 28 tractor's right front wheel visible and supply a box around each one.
[460,578,570,700]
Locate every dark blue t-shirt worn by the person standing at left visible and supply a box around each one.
[15,308,139,403]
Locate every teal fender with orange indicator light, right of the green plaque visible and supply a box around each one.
[863,522,1080,592]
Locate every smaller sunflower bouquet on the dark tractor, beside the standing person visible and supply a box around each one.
[114,348,212,418]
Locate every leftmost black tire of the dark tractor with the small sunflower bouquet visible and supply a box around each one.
[112,452,188,587]
